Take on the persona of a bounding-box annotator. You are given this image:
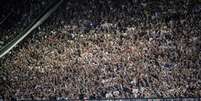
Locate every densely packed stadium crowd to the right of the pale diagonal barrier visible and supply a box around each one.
[0,0,201,99]
